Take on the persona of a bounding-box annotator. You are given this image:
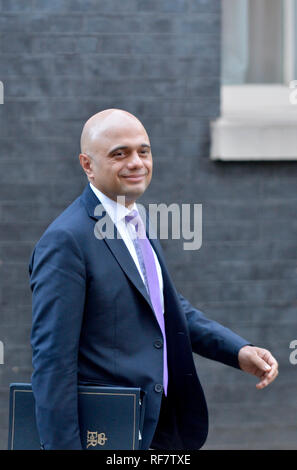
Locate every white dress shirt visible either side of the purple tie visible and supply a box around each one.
[89,183,164,313]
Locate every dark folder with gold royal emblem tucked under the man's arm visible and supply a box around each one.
[8,383,145,450]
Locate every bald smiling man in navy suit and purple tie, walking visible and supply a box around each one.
[30,109,278,449]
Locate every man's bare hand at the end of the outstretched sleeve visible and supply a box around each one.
[238,346,278,389]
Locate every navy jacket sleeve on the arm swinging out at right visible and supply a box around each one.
[178,294,252,369]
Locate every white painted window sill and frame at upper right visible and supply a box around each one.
[210,0,297,161]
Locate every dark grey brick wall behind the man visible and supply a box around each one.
[0,0,297,449]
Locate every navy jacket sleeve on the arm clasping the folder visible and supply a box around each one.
[29,230,85,449]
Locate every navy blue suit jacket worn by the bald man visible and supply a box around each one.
[29,185,248,449]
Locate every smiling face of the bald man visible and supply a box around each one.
[79,116,153,205]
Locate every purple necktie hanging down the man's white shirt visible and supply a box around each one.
[125,210,168,395]
